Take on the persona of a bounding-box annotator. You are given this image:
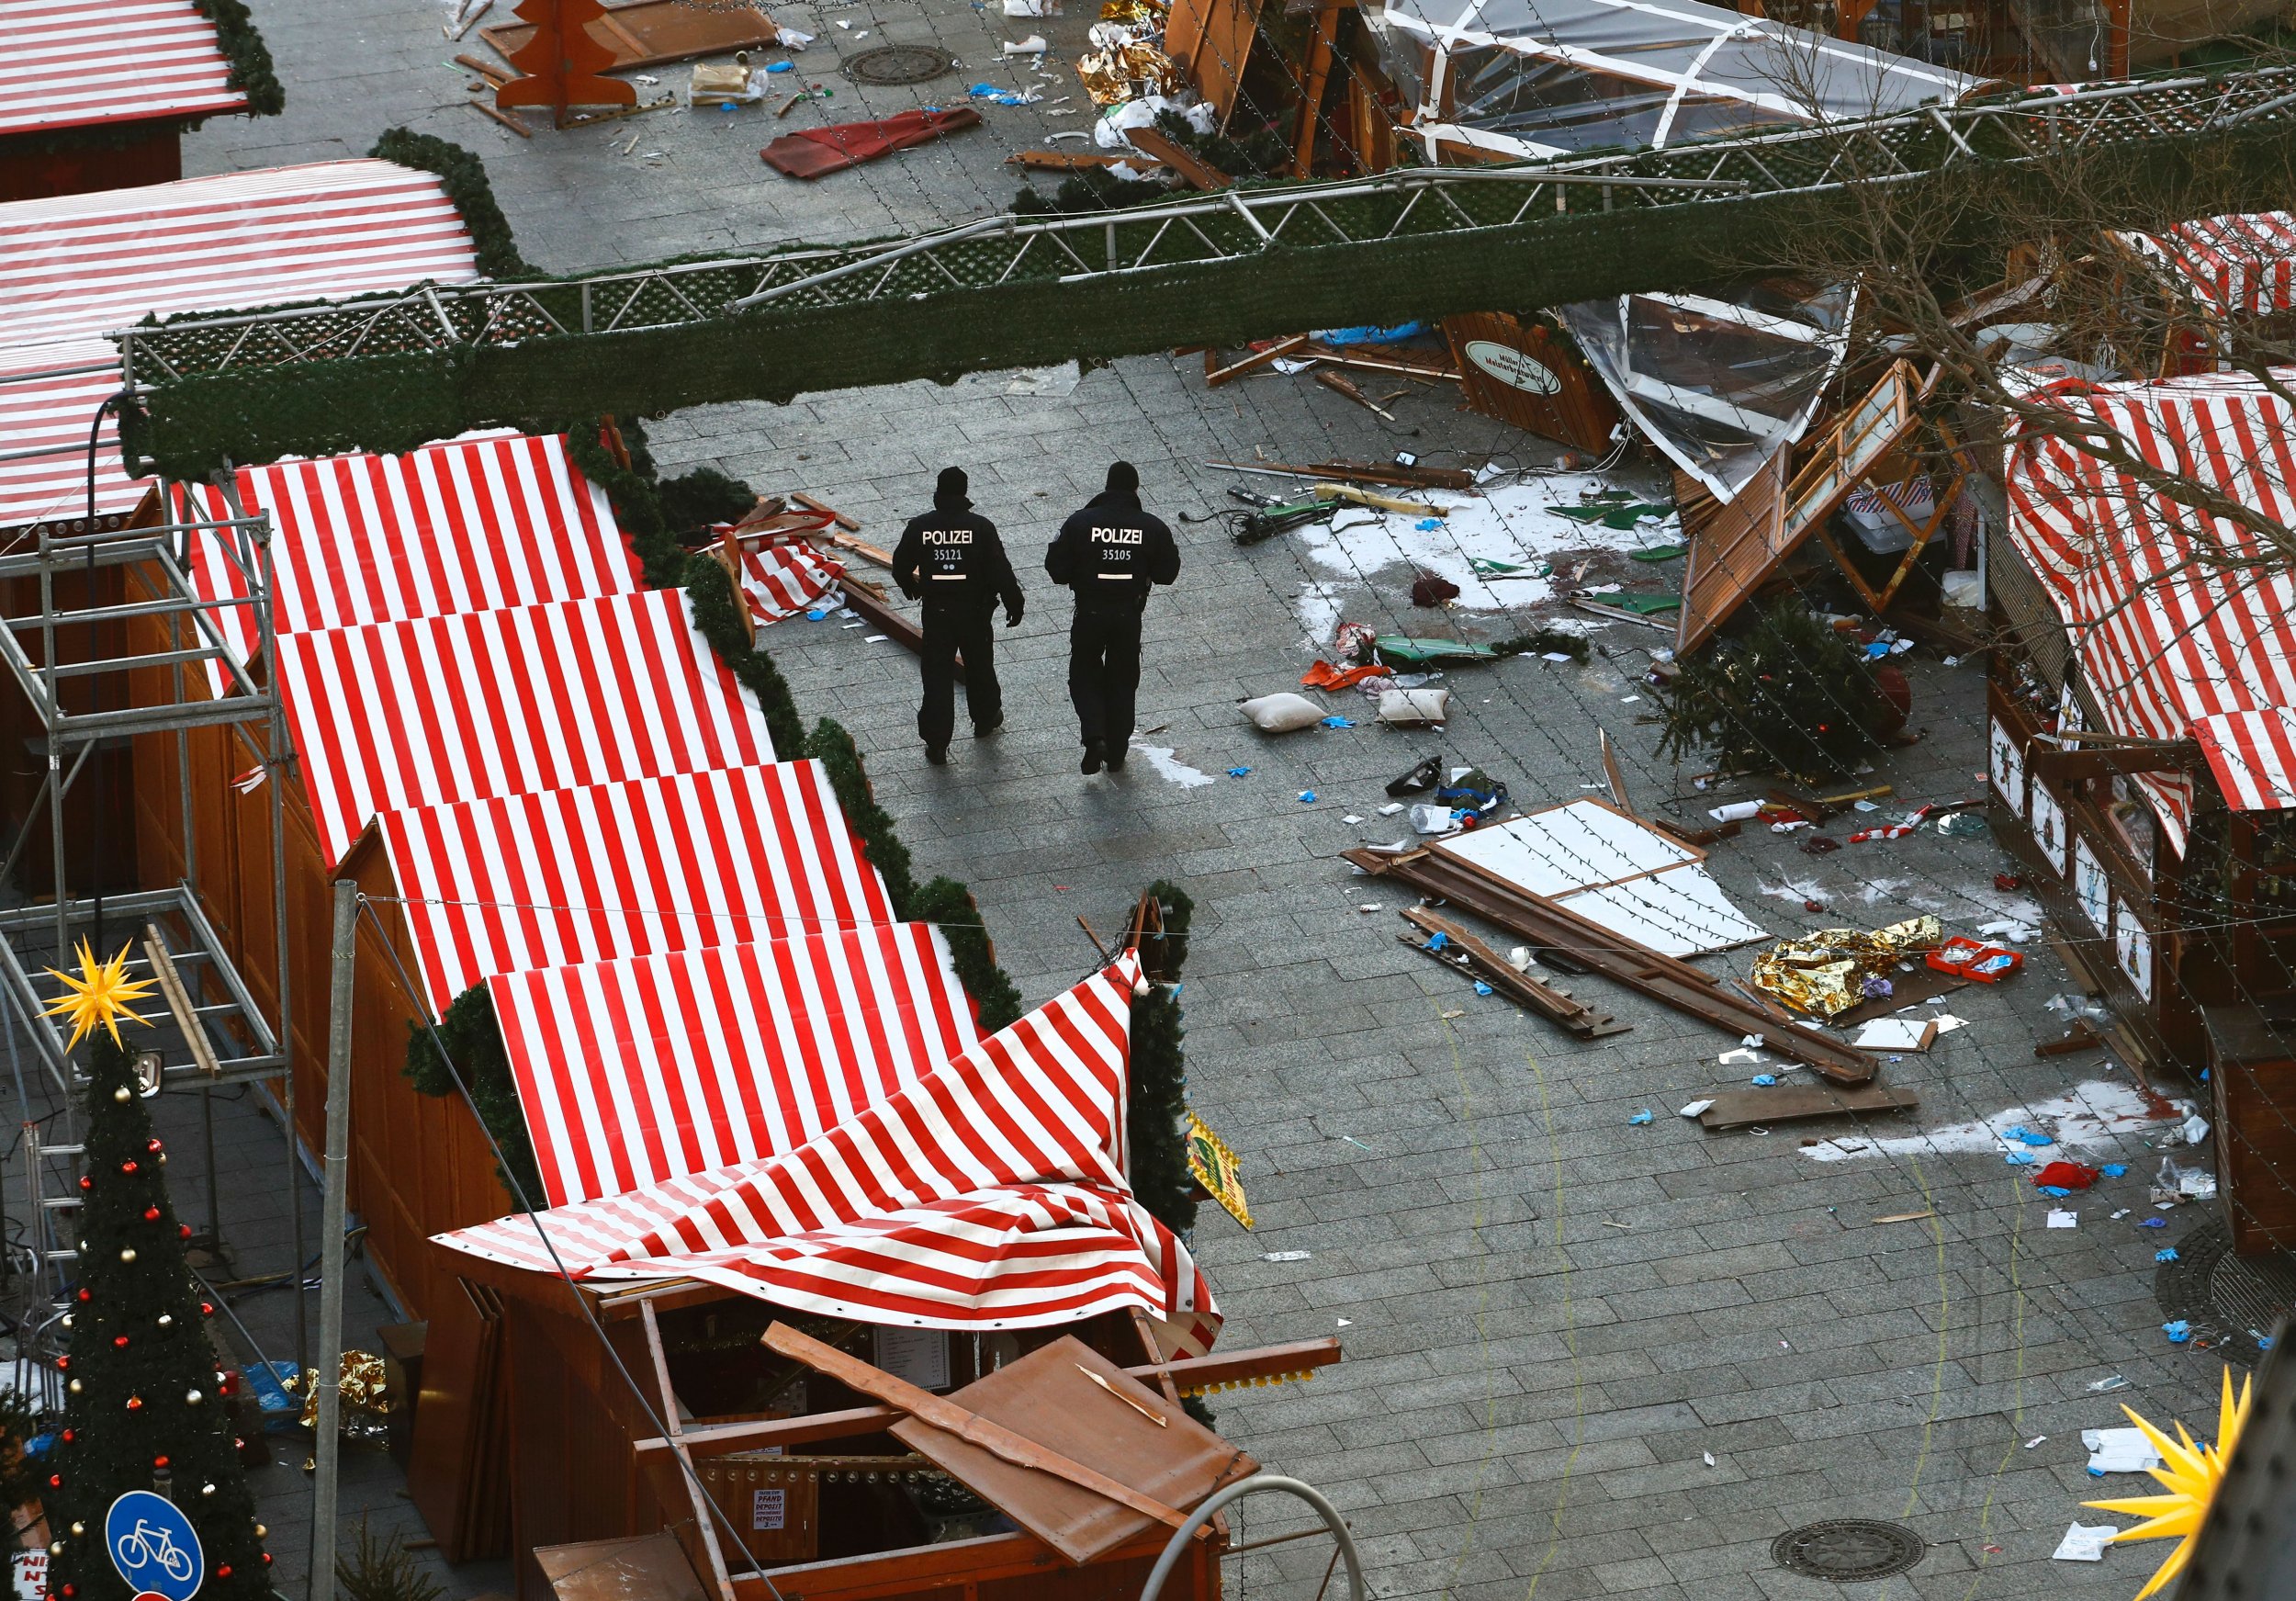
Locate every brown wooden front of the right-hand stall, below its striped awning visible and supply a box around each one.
[1986,634,2296,1254]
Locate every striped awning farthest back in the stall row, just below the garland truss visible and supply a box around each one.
[186,434,646,661]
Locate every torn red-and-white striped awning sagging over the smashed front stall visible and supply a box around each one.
[436,953,1220,1355]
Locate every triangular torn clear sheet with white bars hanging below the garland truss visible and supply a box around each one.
[1561,278,1851,501]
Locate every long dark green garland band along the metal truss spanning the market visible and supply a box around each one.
[122,129,2291,480]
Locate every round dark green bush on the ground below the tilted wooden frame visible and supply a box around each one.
[1658,595,1895,781]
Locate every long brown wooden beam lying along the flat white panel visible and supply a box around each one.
[1341,850,1881,1084]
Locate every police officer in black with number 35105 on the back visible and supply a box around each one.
[1045,462,1180,774]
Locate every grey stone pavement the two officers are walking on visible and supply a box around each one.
[166,0,2216,1601]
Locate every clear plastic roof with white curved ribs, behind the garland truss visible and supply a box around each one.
[1380,0,1977,156]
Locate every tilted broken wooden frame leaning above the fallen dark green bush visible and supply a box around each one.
[1674,361,1968,652]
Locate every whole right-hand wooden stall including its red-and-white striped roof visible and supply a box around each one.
[1986,377,2296,1252]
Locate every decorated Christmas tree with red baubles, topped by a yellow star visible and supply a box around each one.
[41,949,271,1601]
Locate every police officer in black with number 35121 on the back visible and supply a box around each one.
[894,467,1022,767]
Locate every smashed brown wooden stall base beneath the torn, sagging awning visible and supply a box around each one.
[436,1247,1339,1601]
